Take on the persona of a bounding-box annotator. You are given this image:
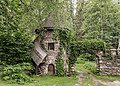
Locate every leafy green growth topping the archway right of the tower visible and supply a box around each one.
[75,39,105,53]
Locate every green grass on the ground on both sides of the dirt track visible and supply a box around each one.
[0,62,120,86]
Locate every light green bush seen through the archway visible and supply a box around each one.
[83,62,97,73]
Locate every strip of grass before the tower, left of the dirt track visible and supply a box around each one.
[0,76,77,86]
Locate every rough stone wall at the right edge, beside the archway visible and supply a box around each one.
[97,49,120,75]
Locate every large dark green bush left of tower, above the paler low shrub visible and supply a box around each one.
[0,31,32,64]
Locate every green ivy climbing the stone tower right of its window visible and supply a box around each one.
[54,28,70,76]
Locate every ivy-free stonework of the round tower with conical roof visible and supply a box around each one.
[32,15,68,75]
